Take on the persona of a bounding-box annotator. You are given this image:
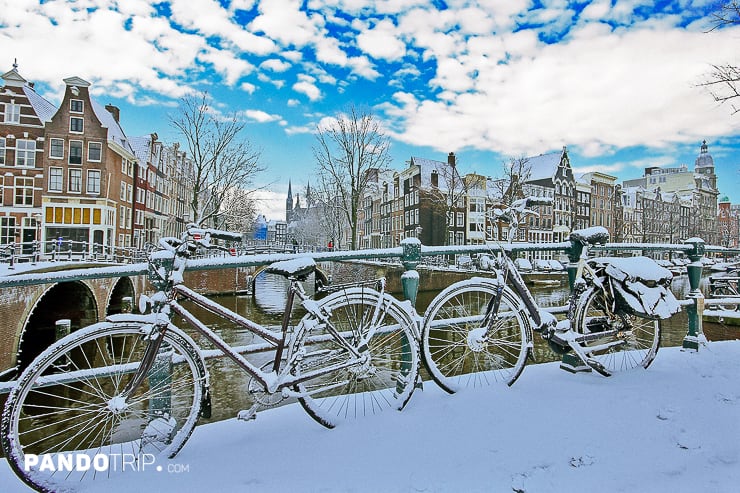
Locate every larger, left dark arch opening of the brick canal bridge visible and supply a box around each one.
[15,281,98,371]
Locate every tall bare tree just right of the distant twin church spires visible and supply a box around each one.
[313,106,390,250]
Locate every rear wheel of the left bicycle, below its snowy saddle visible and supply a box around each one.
[294,288,419,428]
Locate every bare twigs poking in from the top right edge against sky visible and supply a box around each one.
[700,0,740,114]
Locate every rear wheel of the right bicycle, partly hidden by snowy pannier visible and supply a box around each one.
[573,286,660,376]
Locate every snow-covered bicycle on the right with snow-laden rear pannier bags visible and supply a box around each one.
[421,197,679,393]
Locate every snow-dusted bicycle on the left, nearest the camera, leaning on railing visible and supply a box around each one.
[0,227,419,491]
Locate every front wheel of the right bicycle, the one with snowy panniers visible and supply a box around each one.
[421,278,531,393]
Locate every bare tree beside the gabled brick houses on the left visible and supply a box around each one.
[170,93,264,224]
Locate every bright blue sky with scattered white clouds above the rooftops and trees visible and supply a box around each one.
[0,0,740,219]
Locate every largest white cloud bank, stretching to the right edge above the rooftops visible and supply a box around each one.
[386,20,740,155]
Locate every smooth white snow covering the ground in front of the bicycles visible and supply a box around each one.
[0,341,740,493]
